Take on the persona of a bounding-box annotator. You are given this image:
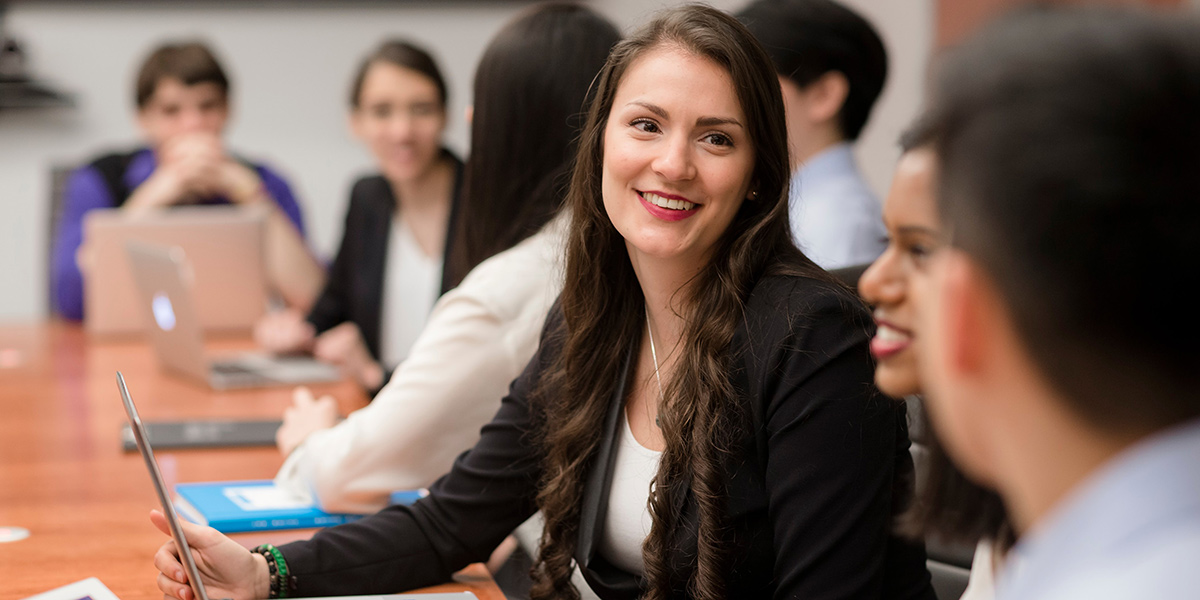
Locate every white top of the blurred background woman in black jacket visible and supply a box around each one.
[379,212,442,368]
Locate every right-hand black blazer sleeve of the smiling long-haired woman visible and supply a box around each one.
[752,286,902,600]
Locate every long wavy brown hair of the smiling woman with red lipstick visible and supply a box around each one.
[530,5,824,600]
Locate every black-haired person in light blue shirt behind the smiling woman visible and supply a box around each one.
[738,0,888,269]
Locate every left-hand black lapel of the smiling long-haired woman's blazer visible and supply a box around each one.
[575,353,632,569]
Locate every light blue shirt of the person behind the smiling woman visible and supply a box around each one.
[788,143,887,269]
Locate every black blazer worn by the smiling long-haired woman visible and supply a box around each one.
[281,277,934,600]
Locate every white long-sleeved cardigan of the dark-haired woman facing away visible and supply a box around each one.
[275,215,566,512]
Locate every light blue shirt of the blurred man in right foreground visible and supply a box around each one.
[996,420,1200,600]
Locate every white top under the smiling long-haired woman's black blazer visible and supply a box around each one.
[600,410,662,575]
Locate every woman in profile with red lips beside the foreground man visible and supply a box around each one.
[858,121,1014,600]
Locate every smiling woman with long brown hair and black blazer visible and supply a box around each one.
[152,5,932,600]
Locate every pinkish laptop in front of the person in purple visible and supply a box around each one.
[84,206,268,336]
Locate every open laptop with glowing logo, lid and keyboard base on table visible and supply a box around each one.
[126,241,342,390]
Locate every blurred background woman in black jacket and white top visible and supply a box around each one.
[254,41,462,391]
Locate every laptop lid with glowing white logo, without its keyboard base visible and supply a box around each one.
[126,241,209,382]
